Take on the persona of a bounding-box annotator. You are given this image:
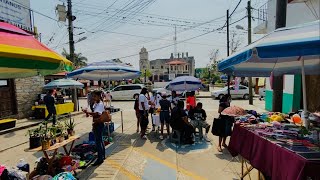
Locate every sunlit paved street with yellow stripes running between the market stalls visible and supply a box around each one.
[0,98,264,179]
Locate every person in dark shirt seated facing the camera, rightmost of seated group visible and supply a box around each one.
[189,102,210,142]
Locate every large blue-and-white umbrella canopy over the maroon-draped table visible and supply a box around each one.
[218,21,320,77]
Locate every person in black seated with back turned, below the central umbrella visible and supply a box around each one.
[170,101,194,144]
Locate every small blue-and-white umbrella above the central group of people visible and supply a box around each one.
[168,76,203,91]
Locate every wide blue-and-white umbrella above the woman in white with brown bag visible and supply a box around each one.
[67,61,141,81]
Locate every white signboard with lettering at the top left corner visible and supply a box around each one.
[0,0,32,32]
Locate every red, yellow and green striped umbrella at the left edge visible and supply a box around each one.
[0,22,72,78]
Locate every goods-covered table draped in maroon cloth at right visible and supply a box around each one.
[228,123,320,180]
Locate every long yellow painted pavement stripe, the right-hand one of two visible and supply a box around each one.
[134,148,207,180]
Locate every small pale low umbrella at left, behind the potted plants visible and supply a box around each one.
[44,79,84,89]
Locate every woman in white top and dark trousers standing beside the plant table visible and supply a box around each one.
[83,91,106,166]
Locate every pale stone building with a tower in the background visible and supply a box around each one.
[139,47,195,82]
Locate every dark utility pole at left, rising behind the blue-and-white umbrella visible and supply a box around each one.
[67,0,78,111]
